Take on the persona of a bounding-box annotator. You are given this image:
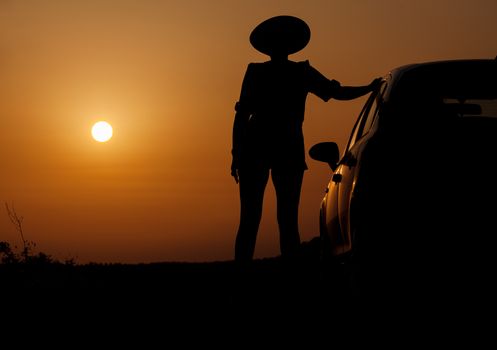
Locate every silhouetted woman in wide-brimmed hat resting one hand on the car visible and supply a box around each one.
[231,16,379,262]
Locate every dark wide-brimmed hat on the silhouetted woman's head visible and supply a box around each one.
[250,16,311,56]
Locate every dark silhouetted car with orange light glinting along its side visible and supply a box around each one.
[309,58,497,295]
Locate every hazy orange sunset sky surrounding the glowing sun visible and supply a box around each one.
[0,0,497,263]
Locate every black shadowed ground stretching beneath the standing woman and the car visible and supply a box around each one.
[0,238,496,349]
